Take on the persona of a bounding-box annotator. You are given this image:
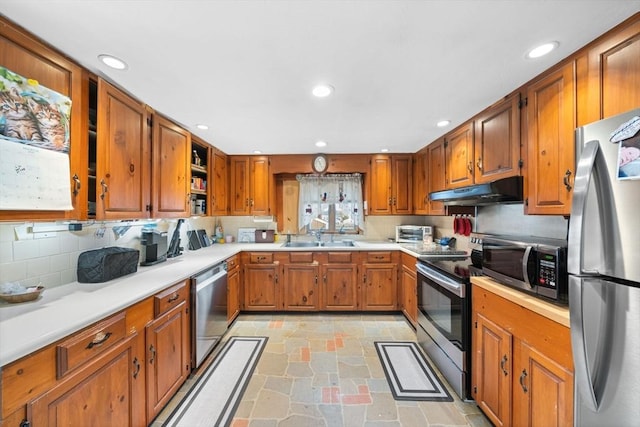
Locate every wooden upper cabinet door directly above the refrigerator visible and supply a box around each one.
[578,19,640,125]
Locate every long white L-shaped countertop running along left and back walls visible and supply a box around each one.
[0,241,416,366]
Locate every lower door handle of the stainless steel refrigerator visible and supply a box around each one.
[569,276,599,412]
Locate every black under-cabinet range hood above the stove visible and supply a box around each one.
[429,176,523,206]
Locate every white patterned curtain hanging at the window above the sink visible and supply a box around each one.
[298,174,364,232]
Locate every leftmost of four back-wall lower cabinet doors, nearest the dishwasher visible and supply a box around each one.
[244,264,282,311]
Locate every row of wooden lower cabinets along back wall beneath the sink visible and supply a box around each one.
[242,251,399,311]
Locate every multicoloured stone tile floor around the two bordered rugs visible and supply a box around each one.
[152,313,491,427]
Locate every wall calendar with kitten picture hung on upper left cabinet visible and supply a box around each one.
[0,66,73,210]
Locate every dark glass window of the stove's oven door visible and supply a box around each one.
[418,274,464,350]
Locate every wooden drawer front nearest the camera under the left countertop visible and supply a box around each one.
[56,312,127,378]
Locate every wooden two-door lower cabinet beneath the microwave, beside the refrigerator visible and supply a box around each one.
[472,285,573,427]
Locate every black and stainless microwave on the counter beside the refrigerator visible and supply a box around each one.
[482,236,568,304]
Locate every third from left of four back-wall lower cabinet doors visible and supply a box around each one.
[321,263,358,311]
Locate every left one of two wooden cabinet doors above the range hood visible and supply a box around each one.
[445,122,473,188]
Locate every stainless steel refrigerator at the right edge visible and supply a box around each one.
[568,109,640,427]
